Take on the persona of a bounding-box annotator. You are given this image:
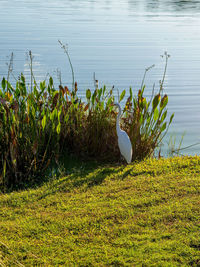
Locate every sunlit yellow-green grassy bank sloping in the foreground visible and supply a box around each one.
[0,156,200,266]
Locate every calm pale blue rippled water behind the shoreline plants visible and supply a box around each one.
[0,0,200,154]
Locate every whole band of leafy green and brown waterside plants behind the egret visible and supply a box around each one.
[0,51,173,190]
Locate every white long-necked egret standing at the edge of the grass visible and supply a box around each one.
[114,103,133,163]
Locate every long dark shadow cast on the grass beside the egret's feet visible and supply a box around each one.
[6,155,129,198]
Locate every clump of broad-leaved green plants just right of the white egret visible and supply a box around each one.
[123,87,174,160]
